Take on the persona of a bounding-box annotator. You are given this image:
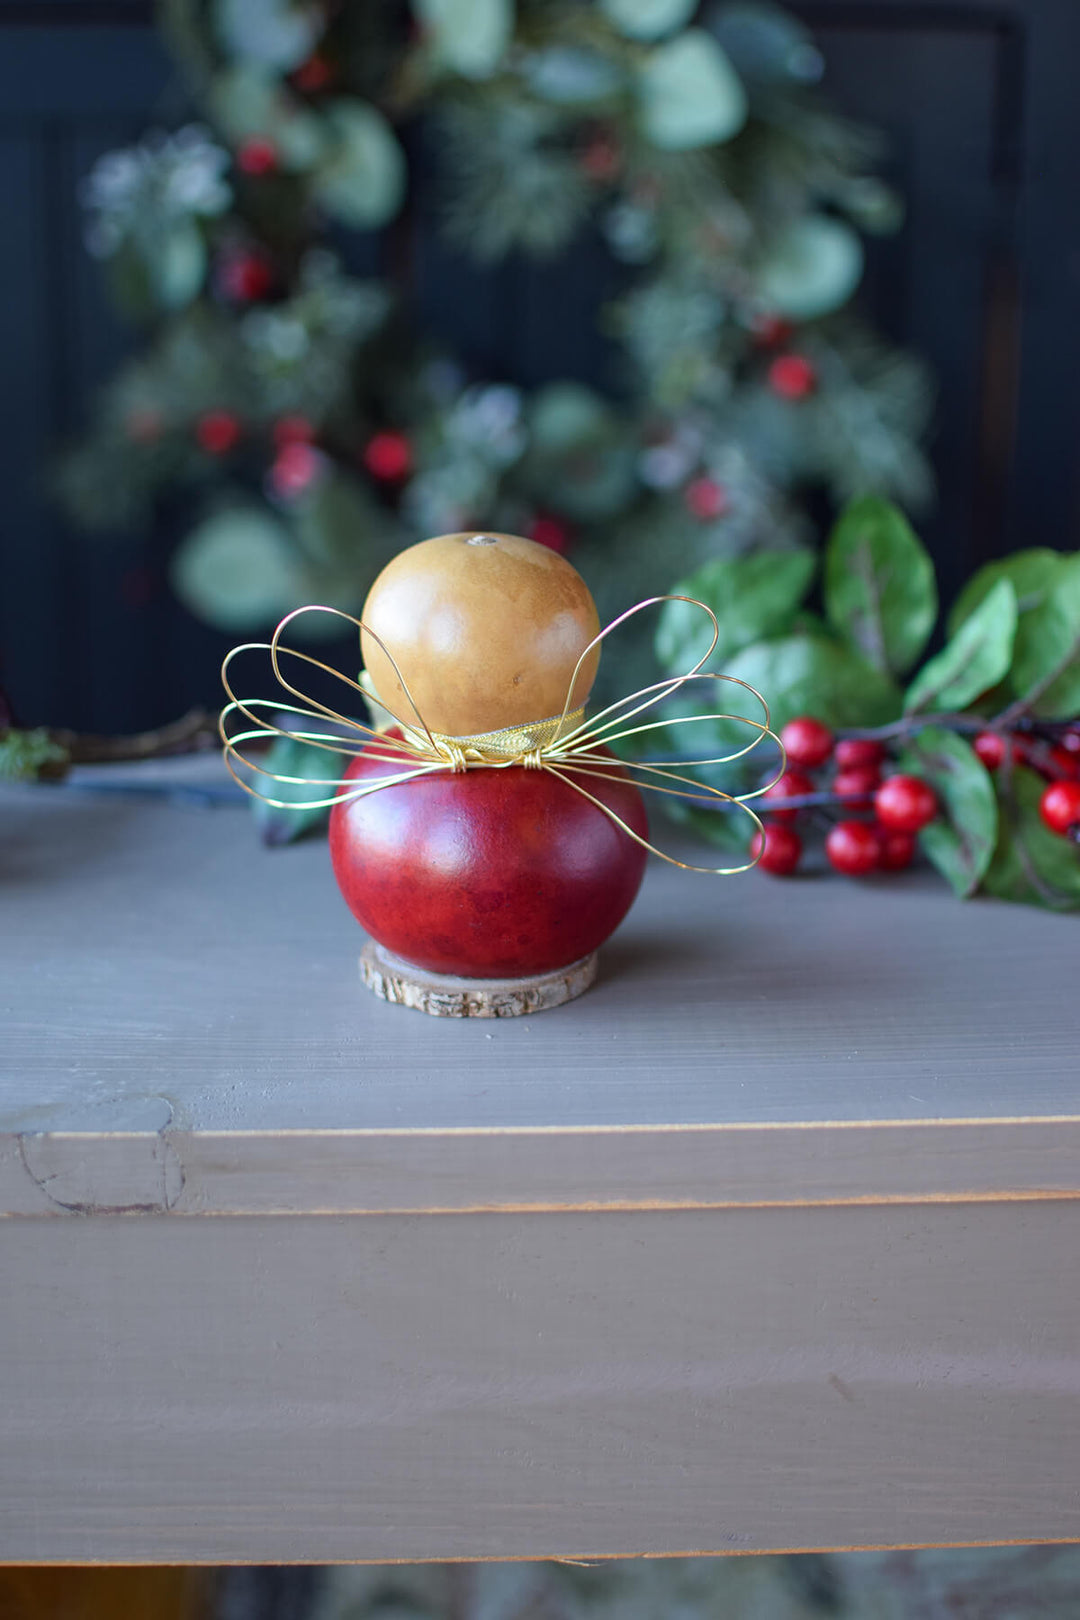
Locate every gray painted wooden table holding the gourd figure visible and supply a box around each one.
[0,771,1080,1562]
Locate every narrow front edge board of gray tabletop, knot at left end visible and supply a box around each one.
[0,1119,1080,1217]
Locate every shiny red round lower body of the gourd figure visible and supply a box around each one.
[330,748,648,978]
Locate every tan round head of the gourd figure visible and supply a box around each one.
[361,530,599,737]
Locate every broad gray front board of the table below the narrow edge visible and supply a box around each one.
[0,1202,1080,1563]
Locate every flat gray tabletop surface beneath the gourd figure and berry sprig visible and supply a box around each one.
[0,776,1080,1153]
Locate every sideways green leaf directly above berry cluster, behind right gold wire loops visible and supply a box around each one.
[709,635,900,731]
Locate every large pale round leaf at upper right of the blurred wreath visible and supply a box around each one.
[638,28,748,152]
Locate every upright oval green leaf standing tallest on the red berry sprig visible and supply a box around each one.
[824,496,938,674]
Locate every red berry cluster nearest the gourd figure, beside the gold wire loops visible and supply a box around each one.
[753,714,938,878]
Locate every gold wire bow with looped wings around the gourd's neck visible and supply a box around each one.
[219,596,787,876]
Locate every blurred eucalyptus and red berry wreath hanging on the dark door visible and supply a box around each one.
[60,0,933,709]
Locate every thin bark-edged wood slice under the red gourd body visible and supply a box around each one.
[359,940,597,1017]
